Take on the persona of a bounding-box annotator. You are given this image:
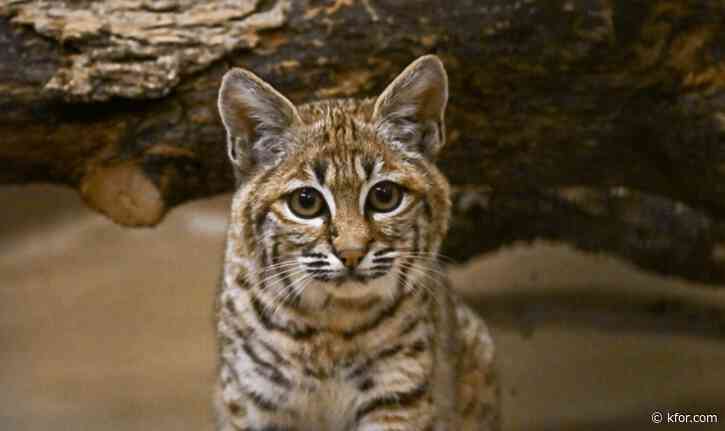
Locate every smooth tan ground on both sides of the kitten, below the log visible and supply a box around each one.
[0,186,725,431]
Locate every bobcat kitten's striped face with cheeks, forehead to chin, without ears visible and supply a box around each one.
[256,135,446,304]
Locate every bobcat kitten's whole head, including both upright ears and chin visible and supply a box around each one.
[220,57,450,304]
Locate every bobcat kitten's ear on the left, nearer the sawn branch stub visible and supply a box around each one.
[219,69,302,172]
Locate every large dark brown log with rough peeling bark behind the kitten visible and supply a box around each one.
[0,0,725,285]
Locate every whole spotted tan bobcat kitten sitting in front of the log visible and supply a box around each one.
[216,56,498,431]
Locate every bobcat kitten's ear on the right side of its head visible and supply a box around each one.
[373,55,448,159]
